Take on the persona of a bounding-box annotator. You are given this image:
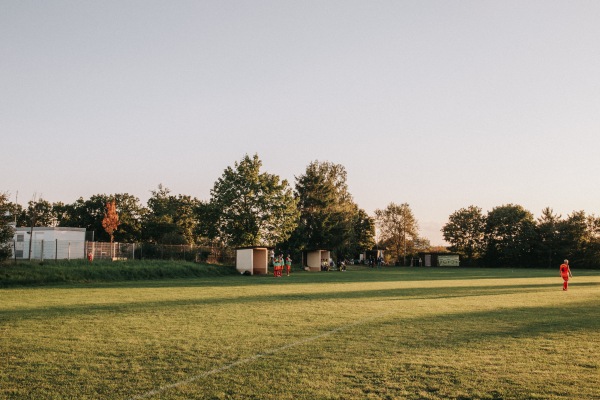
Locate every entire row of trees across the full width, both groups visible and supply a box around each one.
[0,155,600,267]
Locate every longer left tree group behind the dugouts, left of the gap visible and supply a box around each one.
[0,155,428,260]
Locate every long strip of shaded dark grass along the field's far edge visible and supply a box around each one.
[5,262,600,290]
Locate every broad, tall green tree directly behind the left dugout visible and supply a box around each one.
[200,154,298,247]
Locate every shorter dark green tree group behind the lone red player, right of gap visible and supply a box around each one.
[442,204,600,268]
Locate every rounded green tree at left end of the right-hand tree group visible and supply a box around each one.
[442,206,485,265]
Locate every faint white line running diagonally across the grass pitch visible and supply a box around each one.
[129,312,393,400]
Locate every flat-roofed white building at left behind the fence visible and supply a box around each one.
[13,227,85,260]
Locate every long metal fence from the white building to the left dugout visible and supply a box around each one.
[11,239,235,265]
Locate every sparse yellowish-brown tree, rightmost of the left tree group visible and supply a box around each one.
[375,202,419,265]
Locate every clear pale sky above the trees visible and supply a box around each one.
[0,0,600,245]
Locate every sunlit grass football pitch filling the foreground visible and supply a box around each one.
[0,268,600,399]
